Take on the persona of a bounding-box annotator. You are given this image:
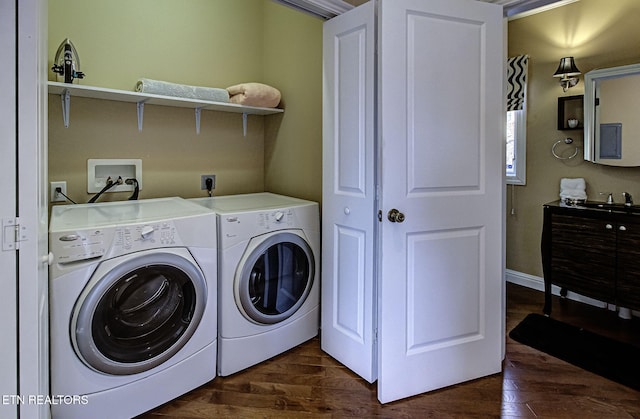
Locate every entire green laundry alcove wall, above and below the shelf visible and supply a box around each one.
[49,0,322,202]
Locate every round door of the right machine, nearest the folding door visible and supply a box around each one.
[236,233,315,324]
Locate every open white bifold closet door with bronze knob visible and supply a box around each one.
[322,0,504,403]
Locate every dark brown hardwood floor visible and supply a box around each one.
[141,284,640,419]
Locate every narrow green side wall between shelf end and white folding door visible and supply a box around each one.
[264,2,323,201]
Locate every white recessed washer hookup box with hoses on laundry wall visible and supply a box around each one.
[87,159,142,193]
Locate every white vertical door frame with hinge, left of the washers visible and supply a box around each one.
[15,0,50,418]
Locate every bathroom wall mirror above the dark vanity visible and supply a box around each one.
[584,64,640,166]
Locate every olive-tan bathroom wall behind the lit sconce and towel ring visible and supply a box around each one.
[506,0,640,277]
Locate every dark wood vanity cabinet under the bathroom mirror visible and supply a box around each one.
[542,202,640,314]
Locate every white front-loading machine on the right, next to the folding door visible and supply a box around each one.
[192,193,320,376]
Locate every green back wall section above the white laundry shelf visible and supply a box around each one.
[49,0,265,90]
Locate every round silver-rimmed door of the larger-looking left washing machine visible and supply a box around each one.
[72,253,206,374]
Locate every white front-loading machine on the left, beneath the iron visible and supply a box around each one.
[49,198,217,419]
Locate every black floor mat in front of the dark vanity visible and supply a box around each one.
[509,313,640,390]
